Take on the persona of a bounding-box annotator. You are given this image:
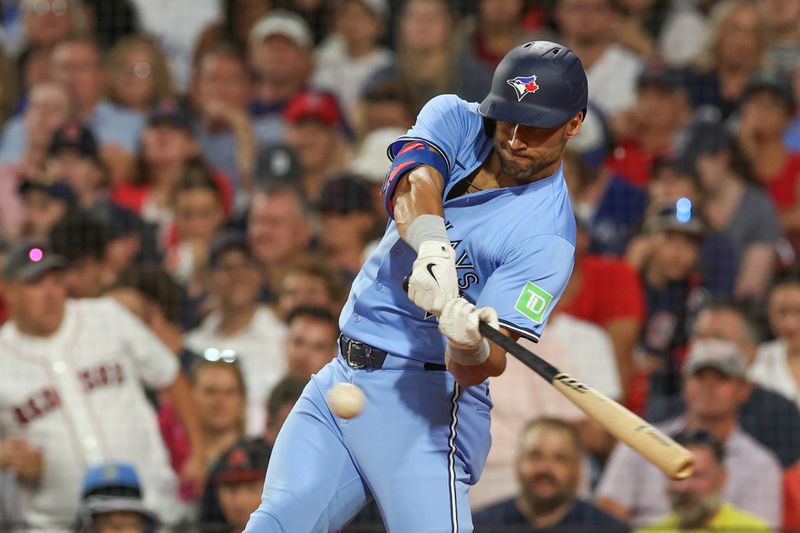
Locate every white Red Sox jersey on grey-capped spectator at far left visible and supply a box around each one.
[0,298,182,531]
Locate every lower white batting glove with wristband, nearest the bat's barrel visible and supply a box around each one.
[439,298,500,366]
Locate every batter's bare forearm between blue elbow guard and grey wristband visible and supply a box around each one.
[392,165,444,242]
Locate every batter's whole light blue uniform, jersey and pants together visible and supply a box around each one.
[245,96,575,533]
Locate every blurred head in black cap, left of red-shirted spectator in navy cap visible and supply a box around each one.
[45,122,109,209]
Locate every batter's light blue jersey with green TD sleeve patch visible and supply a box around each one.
[339,95,575,363]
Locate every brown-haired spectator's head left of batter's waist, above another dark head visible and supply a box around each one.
[275,257,347,321]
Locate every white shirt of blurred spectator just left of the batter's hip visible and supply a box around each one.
[186,306,286,436]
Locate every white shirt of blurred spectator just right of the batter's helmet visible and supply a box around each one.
[586,44,644,116]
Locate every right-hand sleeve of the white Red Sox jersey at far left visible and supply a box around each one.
[109,301,179,390]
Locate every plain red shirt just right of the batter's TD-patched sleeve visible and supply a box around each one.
[561,255,645,327]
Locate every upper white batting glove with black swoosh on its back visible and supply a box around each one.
[408,241,458,315]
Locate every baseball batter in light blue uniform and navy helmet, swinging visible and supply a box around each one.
[246,41,587,533]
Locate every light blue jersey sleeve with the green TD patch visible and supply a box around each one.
[476,235,575,342]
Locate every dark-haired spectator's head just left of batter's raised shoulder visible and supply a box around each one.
[356,80,416,137]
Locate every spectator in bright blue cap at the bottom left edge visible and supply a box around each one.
[74,462,160,533]
